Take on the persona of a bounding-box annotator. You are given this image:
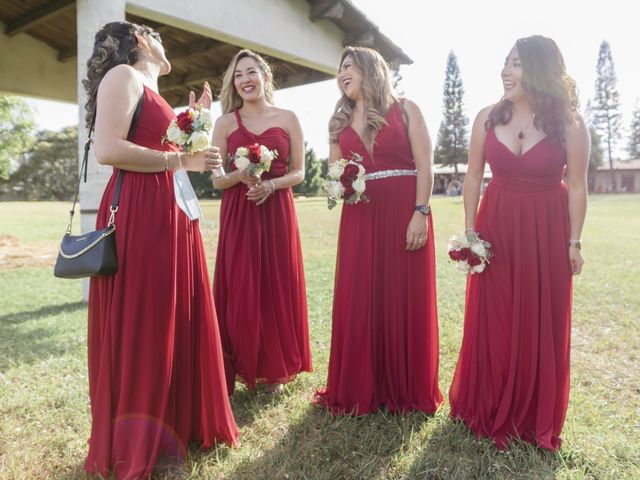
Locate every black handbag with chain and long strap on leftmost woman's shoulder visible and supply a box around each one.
[53,90,144,278]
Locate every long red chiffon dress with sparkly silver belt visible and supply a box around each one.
[315,103,442,415]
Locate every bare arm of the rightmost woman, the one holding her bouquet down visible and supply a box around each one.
[462,107,492,233]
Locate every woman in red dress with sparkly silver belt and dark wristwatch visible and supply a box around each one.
[315,47,442,415]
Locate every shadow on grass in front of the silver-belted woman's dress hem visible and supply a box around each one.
[226,404,432,480]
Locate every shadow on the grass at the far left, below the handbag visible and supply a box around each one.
[0,302,86,371]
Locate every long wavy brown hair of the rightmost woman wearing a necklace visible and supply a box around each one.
[485,35,579,143]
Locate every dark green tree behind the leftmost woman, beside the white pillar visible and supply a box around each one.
[10,126,78,200]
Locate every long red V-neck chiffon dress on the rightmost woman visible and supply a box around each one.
[450,129,572,450]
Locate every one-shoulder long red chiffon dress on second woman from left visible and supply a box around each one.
[213,111,311,393]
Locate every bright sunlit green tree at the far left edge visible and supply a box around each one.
[0,95,33,180]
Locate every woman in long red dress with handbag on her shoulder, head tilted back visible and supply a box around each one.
[84,22,238,479]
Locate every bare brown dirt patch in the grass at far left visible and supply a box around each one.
[0,234,58,270]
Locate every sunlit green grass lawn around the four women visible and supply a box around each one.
[0,195,640,480]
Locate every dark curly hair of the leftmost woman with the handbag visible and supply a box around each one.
[82,21,153,128]
